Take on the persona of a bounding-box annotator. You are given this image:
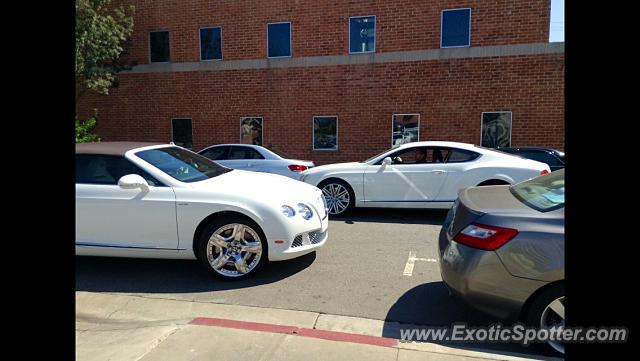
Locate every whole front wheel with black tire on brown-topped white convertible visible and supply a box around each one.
[197,215,268,281]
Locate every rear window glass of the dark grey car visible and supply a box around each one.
[509,169,564,212]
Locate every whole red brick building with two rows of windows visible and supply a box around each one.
[77,0,564,164]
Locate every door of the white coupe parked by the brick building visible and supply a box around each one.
[364,147,448,202]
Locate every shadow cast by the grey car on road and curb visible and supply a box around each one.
[382,282,544,358]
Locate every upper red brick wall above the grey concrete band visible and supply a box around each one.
[120,0,550,64]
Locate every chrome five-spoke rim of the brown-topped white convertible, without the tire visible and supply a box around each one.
[207,223,262,277]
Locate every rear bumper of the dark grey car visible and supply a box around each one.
[438,223,545,321]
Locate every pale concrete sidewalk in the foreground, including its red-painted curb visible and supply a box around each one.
[76,292,550,361]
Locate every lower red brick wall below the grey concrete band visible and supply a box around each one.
[78,54,564,164]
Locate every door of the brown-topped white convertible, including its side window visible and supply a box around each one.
[76,155,178,250]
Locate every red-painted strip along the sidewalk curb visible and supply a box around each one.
[189,317,398,347]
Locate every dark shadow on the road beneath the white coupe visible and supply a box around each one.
[329,208,449,225]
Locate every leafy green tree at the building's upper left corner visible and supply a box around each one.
[76,0,134,102]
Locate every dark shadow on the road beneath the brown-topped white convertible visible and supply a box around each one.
[76,252,316,293]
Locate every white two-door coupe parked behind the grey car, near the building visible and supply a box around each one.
[300,142,549,215]
